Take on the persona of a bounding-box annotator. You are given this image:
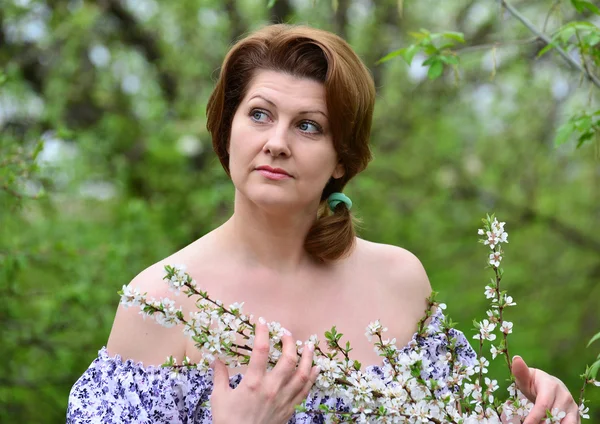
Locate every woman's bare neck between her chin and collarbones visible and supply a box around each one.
[216,191,317,274]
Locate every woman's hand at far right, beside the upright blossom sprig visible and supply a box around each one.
[512,356,581,424]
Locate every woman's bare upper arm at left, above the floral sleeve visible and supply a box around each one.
[106,264,187,365]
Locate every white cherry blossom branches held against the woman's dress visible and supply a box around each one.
[120,216,596,424]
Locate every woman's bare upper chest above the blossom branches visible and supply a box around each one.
[186,264,424,372]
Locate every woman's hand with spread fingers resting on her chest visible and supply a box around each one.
[210,318,319,424]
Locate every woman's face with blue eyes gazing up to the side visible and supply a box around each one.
[228,70,344,212]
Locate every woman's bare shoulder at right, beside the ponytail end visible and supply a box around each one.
[356,239,431,305]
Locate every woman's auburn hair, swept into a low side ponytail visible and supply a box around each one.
[206,24,375,262]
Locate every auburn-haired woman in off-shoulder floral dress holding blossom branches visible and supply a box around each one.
[67,25,579,424]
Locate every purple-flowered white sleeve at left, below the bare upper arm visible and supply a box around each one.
[67,348,212,424]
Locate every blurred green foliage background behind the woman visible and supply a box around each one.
[0,0,600,423]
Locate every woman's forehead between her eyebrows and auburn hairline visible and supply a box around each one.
[245,70,327,113]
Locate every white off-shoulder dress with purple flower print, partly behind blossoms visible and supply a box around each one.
[67,309,477,424]
